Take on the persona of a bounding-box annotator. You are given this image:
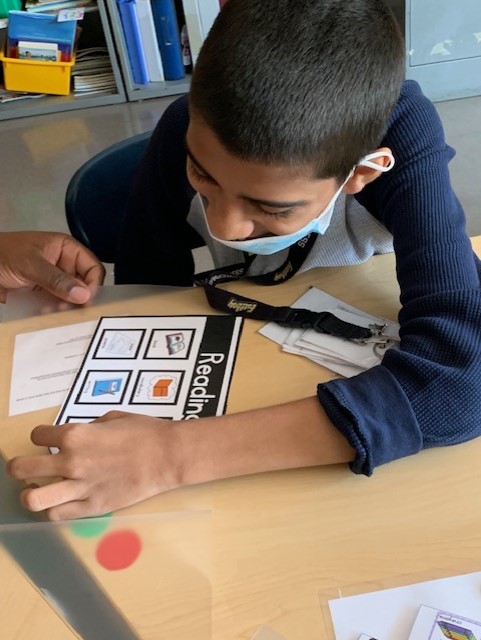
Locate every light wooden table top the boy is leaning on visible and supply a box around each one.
[0,237,481,640]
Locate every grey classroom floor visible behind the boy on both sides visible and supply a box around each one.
[0,90,481,245]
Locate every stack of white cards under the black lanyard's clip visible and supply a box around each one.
[260,287,399,377]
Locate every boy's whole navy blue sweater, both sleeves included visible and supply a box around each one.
[116,81,481,475]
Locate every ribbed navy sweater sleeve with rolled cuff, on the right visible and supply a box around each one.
[318,81,481,475]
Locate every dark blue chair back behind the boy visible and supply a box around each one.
[65,131,152,262]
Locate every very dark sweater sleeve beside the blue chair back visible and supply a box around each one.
[115,96,203,286]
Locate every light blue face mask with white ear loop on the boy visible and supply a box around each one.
[201,151,394,256]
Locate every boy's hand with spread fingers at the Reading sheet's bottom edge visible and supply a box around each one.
[7,411,180,520]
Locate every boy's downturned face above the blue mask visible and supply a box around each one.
[186,118,342,240]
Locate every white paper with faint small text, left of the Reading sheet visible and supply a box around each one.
[10,321,97,416]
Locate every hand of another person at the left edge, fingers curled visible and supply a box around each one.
[0,231,105,304]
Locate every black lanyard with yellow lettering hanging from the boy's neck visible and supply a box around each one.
[194,233,374,341]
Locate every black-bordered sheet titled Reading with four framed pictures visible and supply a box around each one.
[56,316,242,424]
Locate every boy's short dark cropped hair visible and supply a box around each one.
[190,0,404,180]
